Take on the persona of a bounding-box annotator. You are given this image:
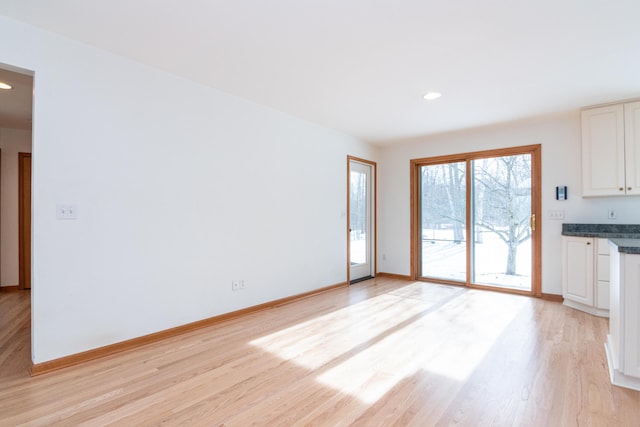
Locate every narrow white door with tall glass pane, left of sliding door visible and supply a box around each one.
[349,160,374,283]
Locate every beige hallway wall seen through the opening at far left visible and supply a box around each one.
[0,128,31,286]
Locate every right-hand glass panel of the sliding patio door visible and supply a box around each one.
[471,154,532,291]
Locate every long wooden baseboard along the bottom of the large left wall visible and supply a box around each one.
[31,282,349,377]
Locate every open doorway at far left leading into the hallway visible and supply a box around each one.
[0,64,34,377]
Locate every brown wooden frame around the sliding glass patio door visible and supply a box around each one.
[410,144,542,297]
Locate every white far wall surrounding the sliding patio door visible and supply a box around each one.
[378,111,640,294]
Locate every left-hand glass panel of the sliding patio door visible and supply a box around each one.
[418,162,467,282]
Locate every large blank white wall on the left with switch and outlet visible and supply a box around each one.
[0,18,377,363]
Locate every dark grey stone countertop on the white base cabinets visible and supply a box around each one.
[562,224,640,254]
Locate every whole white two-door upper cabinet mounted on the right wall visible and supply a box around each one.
[582,101,640,196]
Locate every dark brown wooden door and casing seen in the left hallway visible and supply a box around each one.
[18,153,31,289]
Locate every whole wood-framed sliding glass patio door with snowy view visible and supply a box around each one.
[411,145,541,296]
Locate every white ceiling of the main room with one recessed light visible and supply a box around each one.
[0,0,640,144]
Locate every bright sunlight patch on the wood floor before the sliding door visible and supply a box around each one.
[251,283,528,405]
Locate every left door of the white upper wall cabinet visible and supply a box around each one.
[582,104,625,196]
